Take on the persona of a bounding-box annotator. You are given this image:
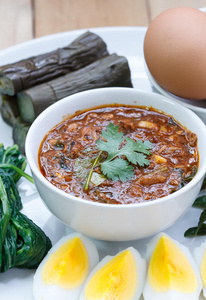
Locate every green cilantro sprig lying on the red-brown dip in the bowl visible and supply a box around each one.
[85,123,151,190]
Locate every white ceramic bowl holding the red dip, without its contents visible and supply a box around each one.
[26,88,206,241]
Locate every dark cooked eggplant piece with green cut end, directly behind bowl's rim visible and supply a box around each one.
[17,54,132,123]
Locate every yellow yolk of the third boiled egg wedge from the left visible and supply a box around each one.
[148,236,198,293]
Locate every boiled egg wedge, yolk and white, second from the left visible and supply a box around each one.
[79,247,146,300]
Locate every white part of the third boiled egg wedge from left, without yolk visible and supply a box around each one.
[143,233,202,300]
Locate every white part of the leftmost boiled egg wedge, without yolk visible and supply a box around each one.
[33,233,99,300]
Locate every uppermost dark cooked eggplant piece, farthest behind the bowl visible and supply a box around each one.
[0,32,108,96]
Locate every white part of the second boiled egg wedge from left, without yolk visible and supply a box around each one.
[79,247,146,300]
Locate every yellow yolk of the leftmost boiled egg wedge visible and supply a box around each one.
[42,237,89,289]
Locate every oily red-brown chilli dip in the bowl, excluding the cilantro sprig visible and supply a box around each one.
[39,106,198,204]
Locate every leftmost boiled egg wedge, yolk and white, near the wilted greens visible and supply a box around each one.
[33,233,99,300]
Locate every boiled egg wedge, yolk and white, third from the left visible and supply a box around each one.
[143,233,202,300]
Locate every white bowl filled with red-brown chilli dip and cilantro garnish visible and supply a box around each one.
[26,88,206,241]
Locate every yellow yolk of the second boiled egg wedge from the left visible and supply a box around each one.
[85,250,137,300]
